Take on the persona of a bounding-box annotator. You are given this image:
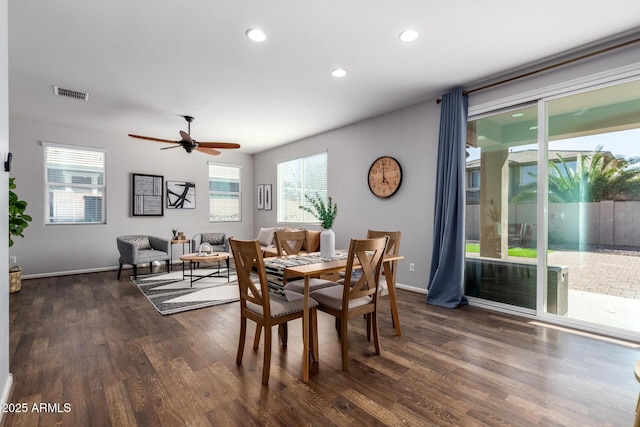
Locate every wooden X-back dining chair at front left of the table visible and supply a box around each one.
[229,238,318,384]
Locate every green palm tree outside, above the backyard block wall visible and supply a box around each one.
[513,146,640,203]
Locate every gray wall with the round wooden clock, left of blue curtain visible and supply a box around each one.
[254,99,440,290]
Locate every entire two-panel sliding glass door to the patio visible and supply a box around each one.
[465,75,640,336]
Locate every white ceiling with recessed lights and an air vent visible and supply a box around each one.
[9,0,640,155]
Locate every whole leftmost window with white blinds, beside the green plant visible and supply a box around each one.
[42,143,106,225]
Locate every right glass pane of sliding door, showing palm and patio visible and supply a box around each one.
[545,80,640,331]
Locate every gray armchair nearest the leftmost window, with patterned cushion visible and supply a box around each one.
[116,235,171,279]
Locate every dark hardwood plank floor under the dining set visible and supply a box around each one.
[3,271,640,426]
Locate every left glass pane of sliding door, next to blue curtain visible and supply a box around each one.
[465,104,538,311]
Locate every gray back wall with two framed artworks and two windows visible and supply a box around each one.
[10,117,253,277]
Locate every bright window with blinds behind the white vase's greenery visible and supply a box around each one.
[277,152,327,223]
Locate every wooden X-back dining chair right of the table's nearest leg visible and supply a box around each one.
[310,236,389,371]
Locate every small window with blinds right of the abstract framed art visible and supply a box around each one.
[209,162,242,222]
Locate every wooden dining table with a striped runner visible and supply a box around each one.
[264,251,404,382]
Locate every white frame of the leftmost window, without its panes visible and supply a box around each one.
[42,141,107,226]
